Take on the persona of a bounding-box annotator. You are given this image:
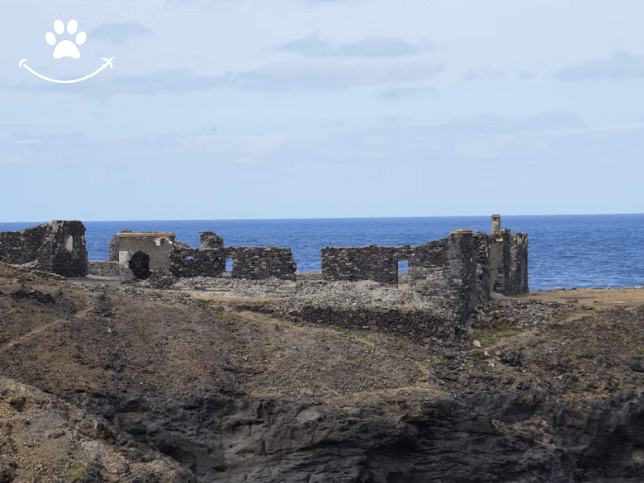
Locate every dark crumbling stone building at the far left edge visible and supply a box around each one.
[0,220,87,277]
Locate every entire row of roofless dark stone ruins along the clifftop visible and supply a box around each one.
[0,215,528,317]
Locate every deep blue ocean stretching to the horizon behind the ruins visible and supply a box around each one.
[0,214,644,290]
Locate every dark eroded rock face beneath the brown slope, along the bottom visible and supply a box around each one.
[82,393,644,483]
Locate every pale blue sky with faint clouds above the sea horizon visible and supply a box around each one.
[0,0,644,222]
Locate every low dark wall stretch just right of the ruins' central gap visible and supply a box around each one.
[320,245,411,284]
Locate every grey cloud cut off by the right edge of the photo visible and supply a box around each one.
[553,51,644,80]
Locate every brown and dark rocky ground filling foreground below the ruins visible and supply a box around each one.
[0,264,644,483]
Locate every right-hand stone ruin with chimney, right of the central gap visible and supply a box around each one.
[321,215,528,324]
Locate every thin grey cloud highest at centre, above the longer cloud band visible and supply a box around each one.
[275,33,433,57]
